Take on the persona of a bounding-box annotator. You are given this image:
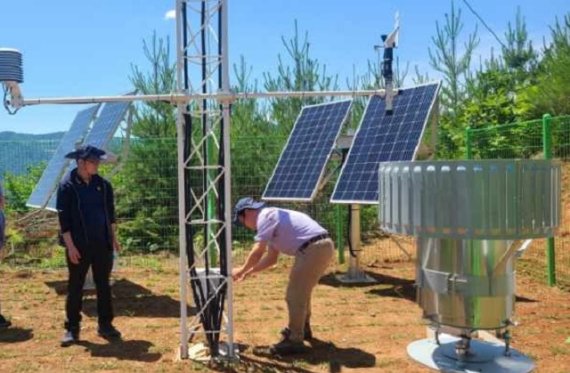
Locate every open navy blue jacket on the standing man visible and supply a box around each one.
[56,168,116,251]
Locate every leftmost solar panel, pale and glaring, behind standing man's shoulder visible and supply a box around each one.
[26,105,100,208]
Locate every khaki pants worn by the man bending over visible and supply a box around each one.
[285,238,334,341]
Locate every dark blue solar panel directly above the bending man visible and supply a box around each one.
[262,100,352,201]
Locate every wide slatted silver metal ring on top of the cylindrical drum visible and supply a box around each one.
[379,160,560,240]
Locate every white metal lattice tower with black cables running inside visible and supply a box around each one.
[176,0,234,358]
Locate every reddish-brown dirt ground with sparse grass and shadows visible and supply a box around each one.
[0,258,570,372]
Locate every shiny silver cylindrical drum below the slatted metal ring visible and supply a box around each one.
[416,238,516,330]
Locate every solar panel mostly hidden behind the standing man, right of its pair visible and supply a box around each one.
[46,102,131,211]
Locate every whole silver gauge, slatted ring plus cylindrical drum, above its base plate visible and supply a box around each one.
[379,160,560,331]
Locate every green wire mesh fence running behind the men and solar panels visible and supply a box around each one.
[0,117,570,286]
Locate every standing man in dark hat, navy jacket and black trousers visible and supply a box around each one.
[56,145,121,346]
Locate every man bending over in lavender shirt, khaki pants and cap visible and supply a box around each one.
[232,197,334,355]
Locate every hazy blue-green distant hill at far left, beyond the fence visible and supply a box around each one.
[0,131,65,178]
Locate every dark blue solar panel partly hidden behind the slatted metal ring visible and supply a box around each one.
[331,83,439,204]
